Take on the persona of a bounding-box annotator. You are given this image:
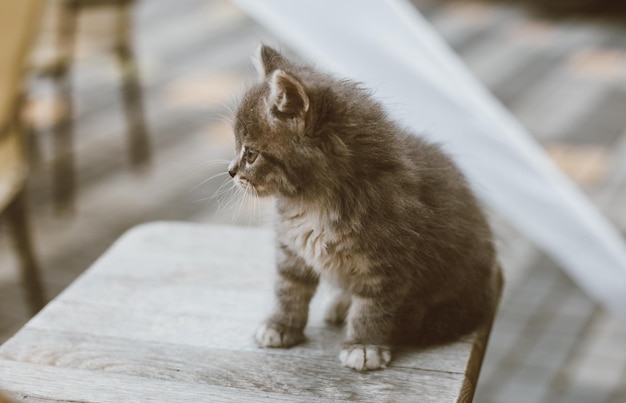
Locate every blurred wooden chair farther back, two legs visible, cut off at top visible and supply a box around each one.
[36,0,150,215]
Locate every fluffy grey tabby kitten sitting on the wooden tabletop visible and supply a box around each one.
[229,46,502,371]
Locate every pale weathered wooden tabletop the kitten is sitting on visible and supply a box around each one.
[0,222,498,402]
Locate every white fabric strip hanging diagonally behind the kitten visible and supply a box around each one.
[234,0,626,318]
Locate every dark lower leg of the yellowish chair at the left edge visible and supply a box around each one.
[6,190,45,314]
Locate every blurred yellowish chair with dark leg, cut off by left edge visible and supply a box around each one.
[0,0,44,312]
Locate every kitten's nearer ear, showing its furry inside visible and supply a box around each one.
[269,70,309,117]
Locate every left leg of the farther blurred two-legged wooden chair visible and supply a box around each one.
[52,4,78,213]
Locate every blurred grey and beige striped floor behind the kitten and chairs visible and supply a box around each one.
[0,0,626,402]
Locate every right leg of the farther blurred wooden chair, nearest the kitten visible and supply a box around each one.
[115,2,151,167]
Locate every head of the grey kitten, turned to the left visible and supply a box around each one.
[228,45,332,200]
